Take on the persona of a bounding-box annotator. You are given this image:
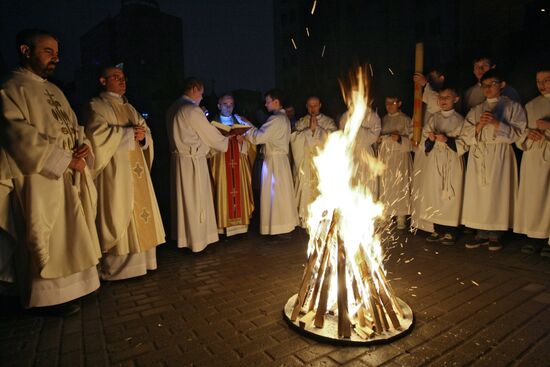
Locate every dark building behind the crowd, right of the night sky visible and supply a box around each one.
[274,0,550,116]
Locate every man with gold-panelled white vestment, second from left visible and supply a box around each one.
[86,67,165,280]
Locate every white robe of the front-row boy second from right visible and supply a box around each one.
[462,96,527,231]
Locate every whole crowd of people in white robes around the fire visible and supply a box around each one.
[0,30,550,315]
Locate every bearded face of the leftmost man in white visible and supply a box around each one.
[21,36,59,78]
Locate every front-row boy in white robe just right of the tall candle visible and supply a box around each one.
[420,87,467,245]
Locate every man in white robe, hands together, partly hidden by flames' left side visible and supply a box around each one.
[290,96,338,228]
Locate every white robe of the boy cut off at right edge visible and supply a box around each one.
[514,95,550,238]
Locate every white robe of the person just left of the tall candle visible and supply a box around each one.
[378,112,412,217]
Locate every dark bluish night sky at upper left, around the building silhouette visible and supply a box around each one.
[0,0,275,94]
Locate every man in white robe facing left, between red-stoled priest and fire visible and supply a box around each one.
[247,89,298,235]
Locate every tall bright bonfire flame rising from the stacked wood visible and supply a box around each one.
[304,68,398,334]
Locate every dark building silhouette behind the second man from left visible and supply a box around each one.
[77,0,183,112]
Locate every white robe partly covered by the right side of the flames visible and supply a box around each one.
[338,108,381,201]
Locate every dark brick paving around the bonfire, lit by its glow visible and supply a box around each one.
[0,231,550,367]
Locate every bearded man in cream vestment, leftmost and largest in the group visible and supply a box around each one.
[0,30,101,315]
